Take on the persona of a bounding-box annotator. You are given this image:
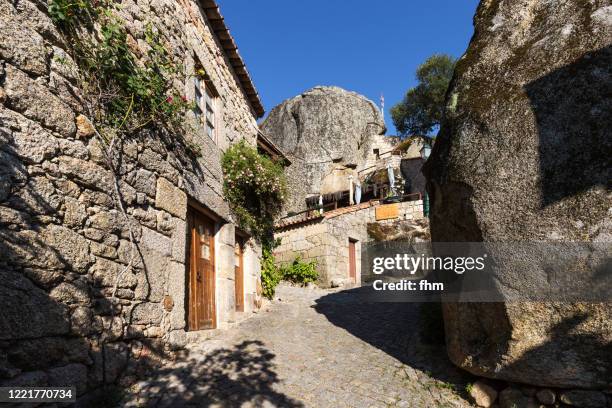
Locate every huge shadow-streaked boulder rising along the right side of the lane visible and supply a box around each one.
[425,0,612,388]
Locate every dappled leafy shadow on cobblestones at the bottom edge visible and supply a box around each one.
[123,341,303,407]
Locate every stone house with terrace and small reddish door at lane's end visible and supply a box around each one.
[274,131,428,287]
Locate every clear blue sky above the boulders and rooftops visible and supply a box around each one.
[218,0,478,134]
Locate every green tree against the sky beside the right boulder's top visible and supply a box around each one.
[391,54,456,136]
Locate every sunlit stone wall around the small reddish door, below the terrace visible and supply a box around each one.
[274,200,423,287]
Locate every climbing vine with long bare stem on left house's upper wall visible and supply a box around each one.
[48,0,193,300]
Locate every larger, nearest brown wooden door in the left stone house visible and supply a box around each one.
[188,211,216,330]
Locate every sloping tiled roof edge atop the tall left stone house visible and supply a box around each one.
[199,0,265,118]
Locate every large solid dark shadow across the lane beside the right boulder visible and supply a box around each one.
[314,287,473,390]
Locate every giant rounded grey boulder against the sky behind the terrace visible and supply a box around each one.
[261,86,385,212]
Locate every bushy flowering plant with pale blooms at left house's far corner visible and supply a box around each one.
[221,140,287,243]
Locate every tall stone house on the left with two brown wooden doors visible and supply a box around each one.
[0,0,278,394]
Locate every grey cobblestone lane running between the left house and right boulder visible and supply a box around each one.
[126,286,471,407]
